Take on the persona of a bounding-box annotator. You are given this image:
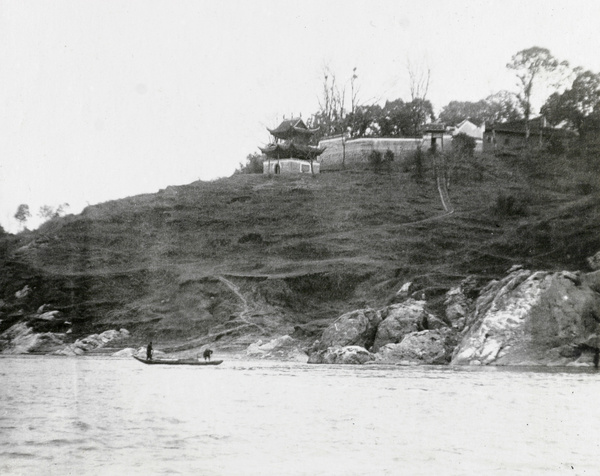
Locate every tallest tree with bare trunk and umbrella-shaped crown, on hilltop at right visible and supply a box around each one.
[506,46,568,139]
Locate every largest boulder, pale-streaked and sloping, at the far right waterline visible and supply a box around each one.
[451,269,600,365]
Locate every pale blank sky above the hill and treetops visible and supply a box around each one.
[0,0,600,232]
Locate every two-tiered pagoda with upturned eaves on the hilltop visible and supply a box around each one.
[259,118,325,174]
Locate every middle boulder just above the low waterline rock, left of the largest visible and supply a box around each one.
[372,299,446,352]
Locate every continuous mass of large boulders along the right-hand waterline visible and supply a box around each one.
[308,258,600,366]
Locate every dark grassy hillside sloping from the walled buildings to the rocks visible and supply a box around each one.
[0,152,600,348]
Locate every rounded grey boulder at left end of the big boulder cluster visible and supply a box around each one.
[312,309,382,351]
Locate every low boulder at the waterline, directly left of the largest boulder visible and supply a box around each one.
[375,329,456,365]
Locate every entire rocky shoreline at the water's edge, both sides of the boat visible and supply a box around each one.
[0,253,600,366]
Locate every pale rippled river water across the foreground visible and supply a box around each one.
[0,357,600,475]
